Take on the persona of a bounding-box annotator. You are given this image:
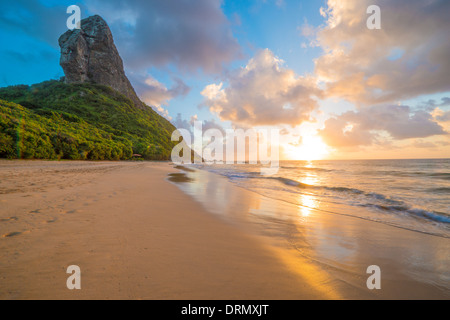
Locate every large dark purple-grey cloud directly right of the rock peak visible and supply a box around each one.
[86,0,241,73]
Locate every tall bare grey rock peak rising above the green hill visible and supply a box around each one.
[59,15,144,108]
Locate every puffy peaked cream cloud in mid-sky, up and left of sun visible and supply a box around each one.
[201,49,320,126]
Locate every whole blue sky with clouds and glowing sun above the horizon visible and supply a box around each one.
[0,0,450,159]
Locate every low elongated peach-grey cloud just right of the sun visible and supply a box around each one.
[319,105,447,147]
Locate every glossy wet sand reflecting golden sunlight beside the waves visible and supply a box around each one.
[168,169,450,299]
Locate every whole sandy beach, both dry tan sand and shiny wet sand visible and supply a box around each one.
[0,161,450,299]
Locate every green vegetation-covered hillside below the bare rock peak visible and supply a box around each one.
[0,81,176,160]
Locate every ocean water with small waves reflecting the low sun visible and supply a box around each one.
[192,159,450,238]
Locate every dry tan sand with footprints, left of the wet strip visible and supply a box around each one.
[0,161,328,299]
